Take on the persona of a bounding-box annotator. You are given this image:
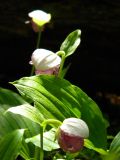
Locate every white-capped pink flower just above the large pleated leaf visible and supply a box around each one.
[30,49,61,74]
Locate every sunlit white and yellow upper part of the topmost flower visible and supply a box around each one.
[28,10,51,27]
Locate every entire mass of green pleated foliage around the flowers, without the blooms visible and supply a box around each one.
[0,29,120,160]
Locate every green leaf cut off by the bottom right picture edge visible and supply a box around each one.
[109,132,120,160]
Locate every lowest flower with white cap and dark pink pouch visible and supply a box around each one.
[58,118,89,153]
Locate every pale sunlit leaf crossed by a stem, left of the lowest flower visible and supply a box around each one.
[25,129,60,151]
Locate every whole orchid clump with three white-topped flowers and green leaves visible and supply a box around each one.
[0,10,115,160]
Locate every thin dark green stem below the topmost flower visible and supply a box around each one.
[30,27,42,76]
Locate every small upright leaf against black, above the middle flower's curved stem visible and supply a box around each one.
[60,29,81,57]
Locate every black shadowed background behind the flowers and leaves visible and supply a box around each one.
[0,0,120,133]
